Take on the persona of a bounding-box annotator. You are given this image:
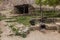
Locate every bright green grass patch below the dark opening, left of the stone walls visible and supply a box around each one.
[17,16,32,25]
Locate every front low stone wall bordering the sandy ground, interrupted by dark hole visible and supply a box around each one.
[30,24,60,31]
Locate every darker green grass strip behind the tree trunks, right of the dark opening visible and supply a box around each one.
[33,10,60,17]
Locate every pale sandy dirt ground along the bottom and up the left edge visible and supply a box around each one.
[0,22,60,40]
